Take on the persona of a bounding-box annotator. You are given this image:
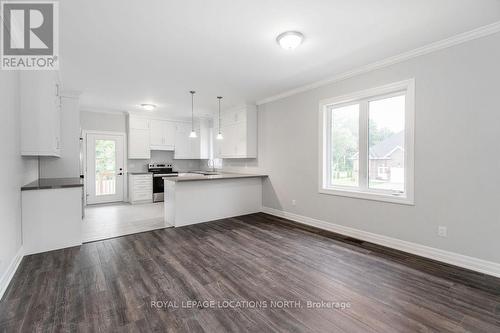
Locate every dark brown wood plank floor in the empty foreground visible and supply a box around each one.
[0,214,500,332]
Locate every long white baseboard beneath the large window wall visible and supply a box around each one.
[262,207,500,277]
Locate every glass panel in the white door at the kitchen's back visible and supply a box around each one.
[95,140,116,196]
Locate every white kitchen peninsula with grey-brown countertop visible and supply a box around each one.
[164,173,267,227]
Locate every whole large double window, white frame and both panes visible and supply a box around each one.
[319,80,414,204]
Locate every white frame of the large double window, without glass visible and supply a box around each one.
[319,79,415,205]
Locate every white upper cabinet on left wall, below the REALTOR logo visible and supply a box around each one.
[20,71,62,157]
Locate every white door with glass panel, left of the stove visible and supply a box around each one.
[86,133,125,204]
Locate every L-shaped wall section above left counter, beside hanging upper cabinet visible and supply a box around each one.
[40,96,80,178]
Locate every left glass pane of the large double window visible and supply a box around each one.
[330,104,359,186]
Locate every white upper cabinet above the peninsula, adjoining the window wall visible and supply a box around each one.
[214,105,257,158]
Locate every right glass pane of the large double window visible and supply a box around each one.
[368,95,405,192]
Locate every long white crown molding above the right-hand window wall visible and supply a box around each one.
[257,21,500,105]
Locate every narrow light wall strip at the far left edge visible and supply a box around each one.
[0,71,38,296]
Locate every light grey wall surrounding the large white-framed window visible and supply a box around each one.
[232,34,500,263]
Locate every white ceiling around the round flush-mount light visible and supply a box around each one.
[60,0,500,116]
